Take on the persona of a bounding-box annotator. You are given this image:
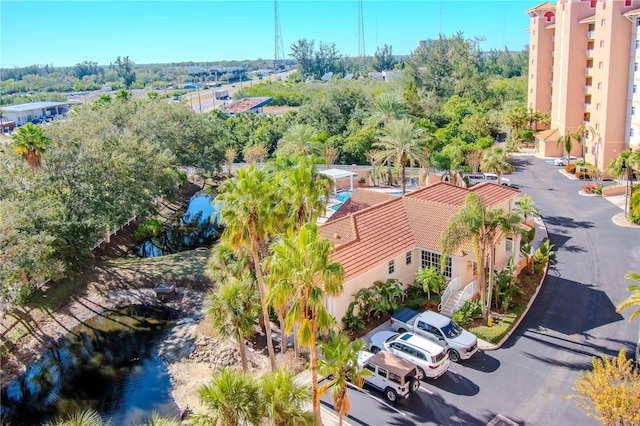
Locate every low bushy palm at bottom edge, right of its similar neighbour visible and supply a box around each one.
[259,368,312,426]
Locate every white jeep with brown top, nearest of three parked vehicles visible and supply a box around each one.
[358,351,420,402]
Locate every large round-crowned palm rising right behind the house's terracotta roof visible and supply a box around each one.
[374,118,427,194]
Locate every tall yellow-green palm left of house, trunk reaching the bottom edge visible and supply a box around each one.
[269,224,344,424]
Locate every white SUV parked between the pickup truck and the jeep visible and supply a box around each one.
[370,331,449,380]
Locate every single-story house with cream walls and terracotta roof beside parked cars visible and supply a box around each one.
[320,182,520,321]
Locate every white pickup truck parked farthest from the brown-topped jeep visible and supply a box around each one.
[389,308,478,362]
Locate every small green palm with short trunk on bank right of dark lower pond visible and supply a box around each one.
[209,275,259,371]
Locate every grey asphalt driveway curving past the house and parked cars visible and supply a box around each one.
[325,157,640,425]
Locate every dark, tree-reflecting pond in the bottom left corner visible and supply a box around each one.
[0,306,180,426]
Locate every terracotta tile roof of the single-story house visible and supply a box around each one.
[320,182,519,280]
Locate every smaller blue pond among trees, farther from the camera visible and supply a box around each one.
[137,193,222,257]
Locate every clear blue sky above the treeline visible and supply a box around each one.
[0,0,540,68]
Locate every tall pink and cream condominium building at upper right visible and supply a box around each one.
[526,0,640,170]
